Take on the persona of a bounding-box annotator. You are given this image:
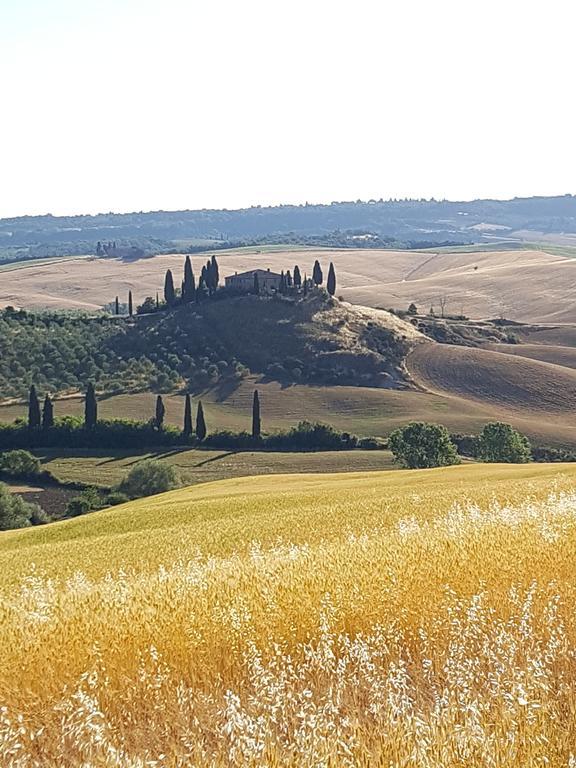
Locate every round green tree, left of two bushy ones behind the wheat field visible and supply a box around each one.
[388,421,460,469]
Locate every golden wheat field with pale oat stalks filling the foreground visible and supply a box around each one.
[0,465,576,768]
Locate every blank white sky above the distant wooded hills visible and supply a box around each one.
[0,0,576,217]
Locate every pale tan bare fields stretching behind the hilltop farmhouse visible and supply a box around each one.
[0,248,576,323]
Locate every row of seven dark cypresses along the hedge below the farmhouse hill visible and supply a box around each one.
[28,383,262,441]
